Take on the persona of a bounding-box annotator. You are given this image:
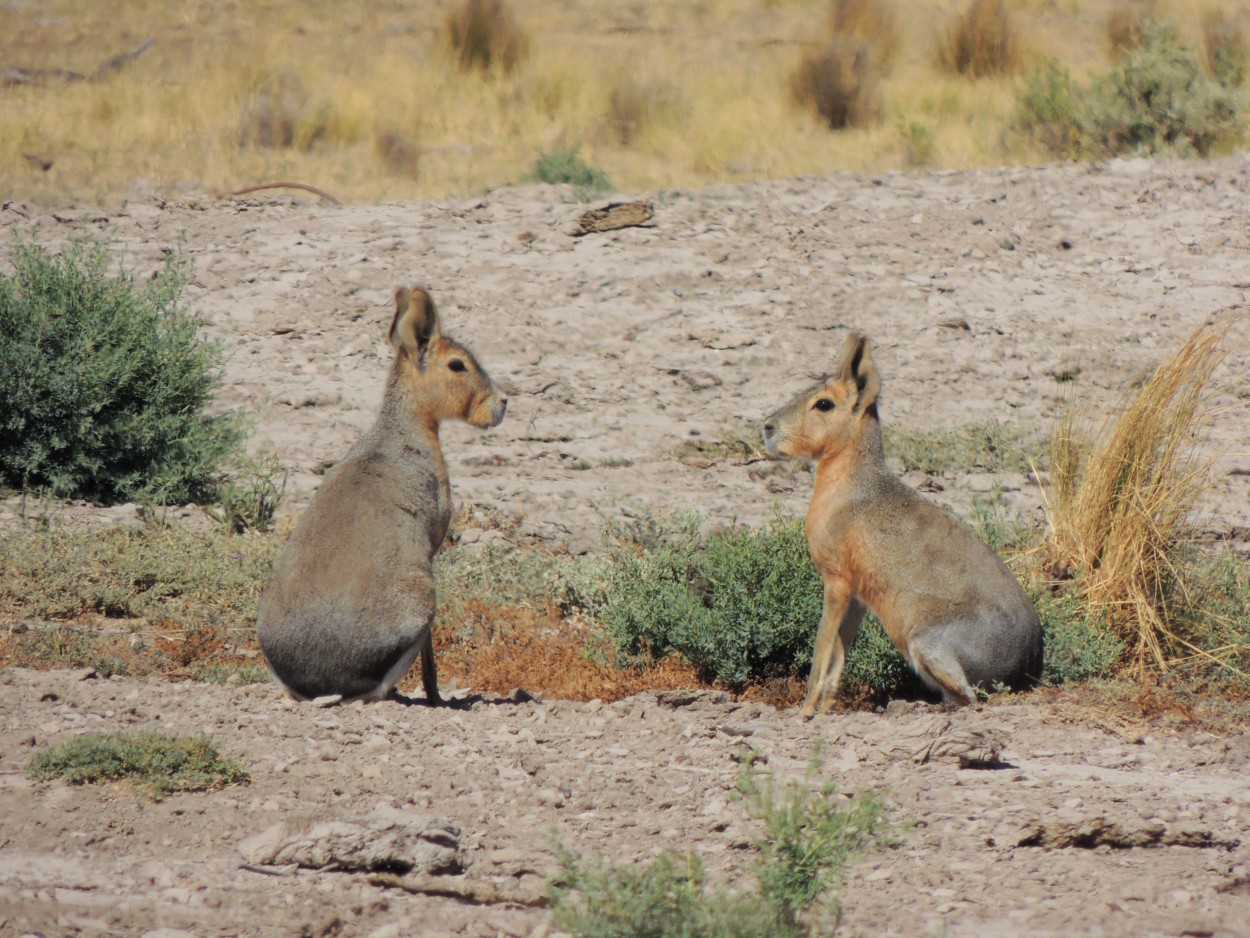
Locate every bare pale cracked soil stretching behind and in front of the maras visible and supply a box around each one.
[0,158,1250,935]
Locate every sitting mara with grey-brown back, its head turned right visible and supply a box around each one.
[256,288,508,704]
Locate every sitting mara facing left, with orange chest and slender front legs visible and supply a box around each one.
[764,335,1041,717]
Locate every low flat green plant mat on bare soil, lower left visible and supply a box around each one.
[26,733,248,800]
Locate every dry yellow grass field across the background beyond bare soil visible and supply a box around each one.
[0,0,1250,205]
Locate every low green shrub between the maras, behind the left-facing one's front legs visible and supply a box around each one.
[573,515,914,693]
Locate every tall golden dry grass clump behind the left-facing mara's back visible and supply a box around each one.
[1048,321,1231,670]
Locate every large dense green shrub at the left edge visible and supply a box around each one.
[0,241,244,503]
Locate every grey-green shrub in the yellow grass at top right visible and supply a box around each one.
[1019,21,1245,156]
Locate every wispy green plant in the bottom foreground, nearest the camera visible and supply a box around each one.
[551,763,885,938]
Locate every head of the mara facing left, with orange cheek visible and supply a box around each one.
[764,333,881,459]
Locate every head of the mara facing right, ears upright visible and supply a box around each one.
[390,286,508,428]
